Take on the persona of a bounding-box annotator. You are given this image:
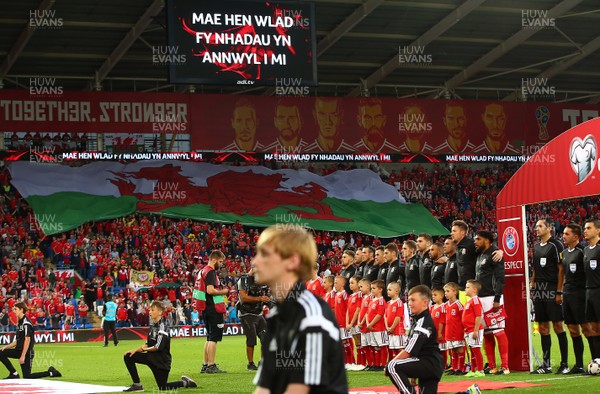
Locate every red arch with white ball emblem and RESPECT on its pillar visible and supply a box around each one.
[496,118,600,370]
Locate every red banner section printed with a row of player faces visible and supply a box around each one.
[191,95,600,155]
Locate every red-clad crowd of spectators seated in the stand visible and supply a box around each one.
[0,161,599,330]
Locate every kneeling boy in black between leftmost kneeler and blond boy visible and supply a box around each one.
[123,301,197,392]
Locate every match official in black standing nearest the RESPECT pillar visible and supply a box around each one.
[529,219,569,374]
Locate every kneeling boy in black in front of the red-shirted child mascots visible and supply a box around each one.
[385,285,444,394]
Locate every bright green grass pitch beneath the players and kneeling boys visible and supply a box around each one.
[21,336,600,394]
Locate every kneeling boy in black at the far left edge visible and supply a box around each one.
[0,302,62,379]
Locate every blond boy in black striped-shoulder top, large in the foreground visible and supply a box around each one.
[254,226,346,394]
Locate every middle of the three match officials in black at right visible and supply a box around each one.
[562,223,594,374]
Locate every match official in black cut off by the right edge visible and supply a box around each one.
[583,219,600,359]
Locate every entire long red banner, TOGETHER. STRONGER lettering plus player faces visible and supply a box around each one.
[0,91,600,155]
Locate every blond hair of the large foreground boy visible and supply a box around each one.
[256,225,317,281]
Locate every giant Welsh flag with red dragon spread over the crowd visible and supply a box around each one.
[10,161,448,237]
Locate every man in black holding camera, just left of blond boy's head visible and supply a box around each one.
[238,265,271,371]
